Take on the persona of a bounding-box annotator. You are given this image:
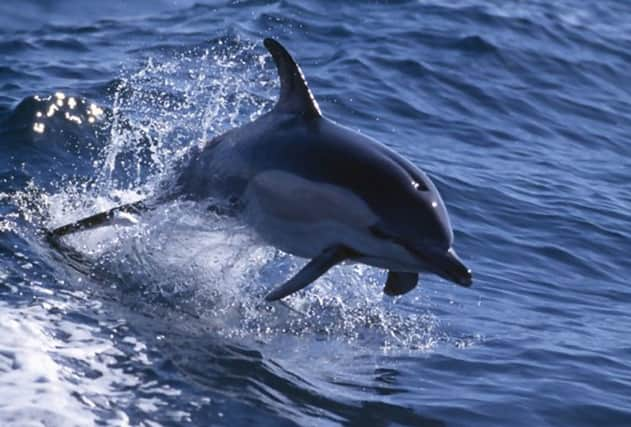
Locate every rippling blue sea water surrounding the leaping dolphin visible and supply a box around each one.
[0,0,631,426]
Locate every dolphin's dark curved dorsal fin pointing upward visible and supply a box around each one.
[263,38,322,118]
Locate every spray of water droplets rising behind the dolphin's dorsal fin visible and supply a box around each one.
[99,39,276,188]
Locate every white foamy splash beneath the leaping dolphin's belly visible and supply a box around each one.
[66,201,451,352]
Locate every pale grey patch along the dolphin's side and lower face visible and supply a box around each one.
[246,170,422,272]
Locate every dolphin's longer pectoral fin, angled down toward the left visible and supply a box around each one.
[265,246,351,301]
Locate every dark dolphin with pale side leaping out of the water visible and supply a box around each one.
[50,38,472,301]
